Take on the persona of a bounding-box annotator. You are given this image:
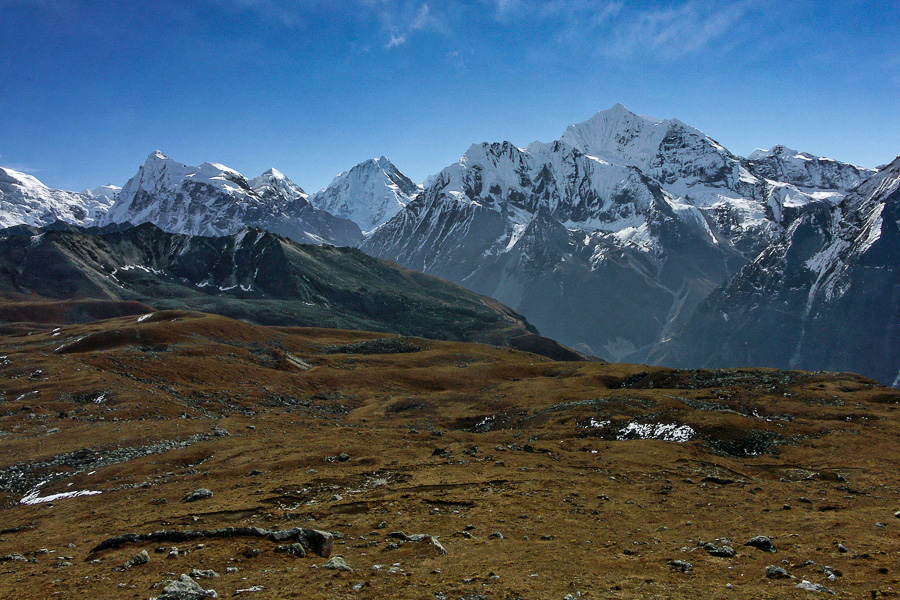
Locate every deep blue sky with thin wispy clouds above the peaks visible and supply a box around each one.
[0,0,900,191]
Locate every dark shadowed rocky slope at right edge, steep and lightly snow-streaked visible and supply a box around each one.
[656,158,900,386]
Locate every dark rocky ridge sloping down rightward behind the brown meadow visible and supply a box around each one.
[0,223,579,359]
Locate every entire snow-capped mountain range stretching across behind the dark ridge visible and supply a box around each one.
[0,105,898,382]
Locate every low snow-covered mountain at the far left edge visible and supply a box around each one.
[0,168,114,229]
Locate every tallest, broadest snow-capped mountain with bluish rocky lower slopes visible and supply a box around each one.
[360,105,876,360]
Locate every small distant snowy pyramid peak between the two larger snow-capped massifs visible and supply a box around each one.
[309,156,422,233]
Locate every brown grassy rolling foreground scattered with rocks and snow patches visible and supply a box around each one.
[0,311,900,600]
